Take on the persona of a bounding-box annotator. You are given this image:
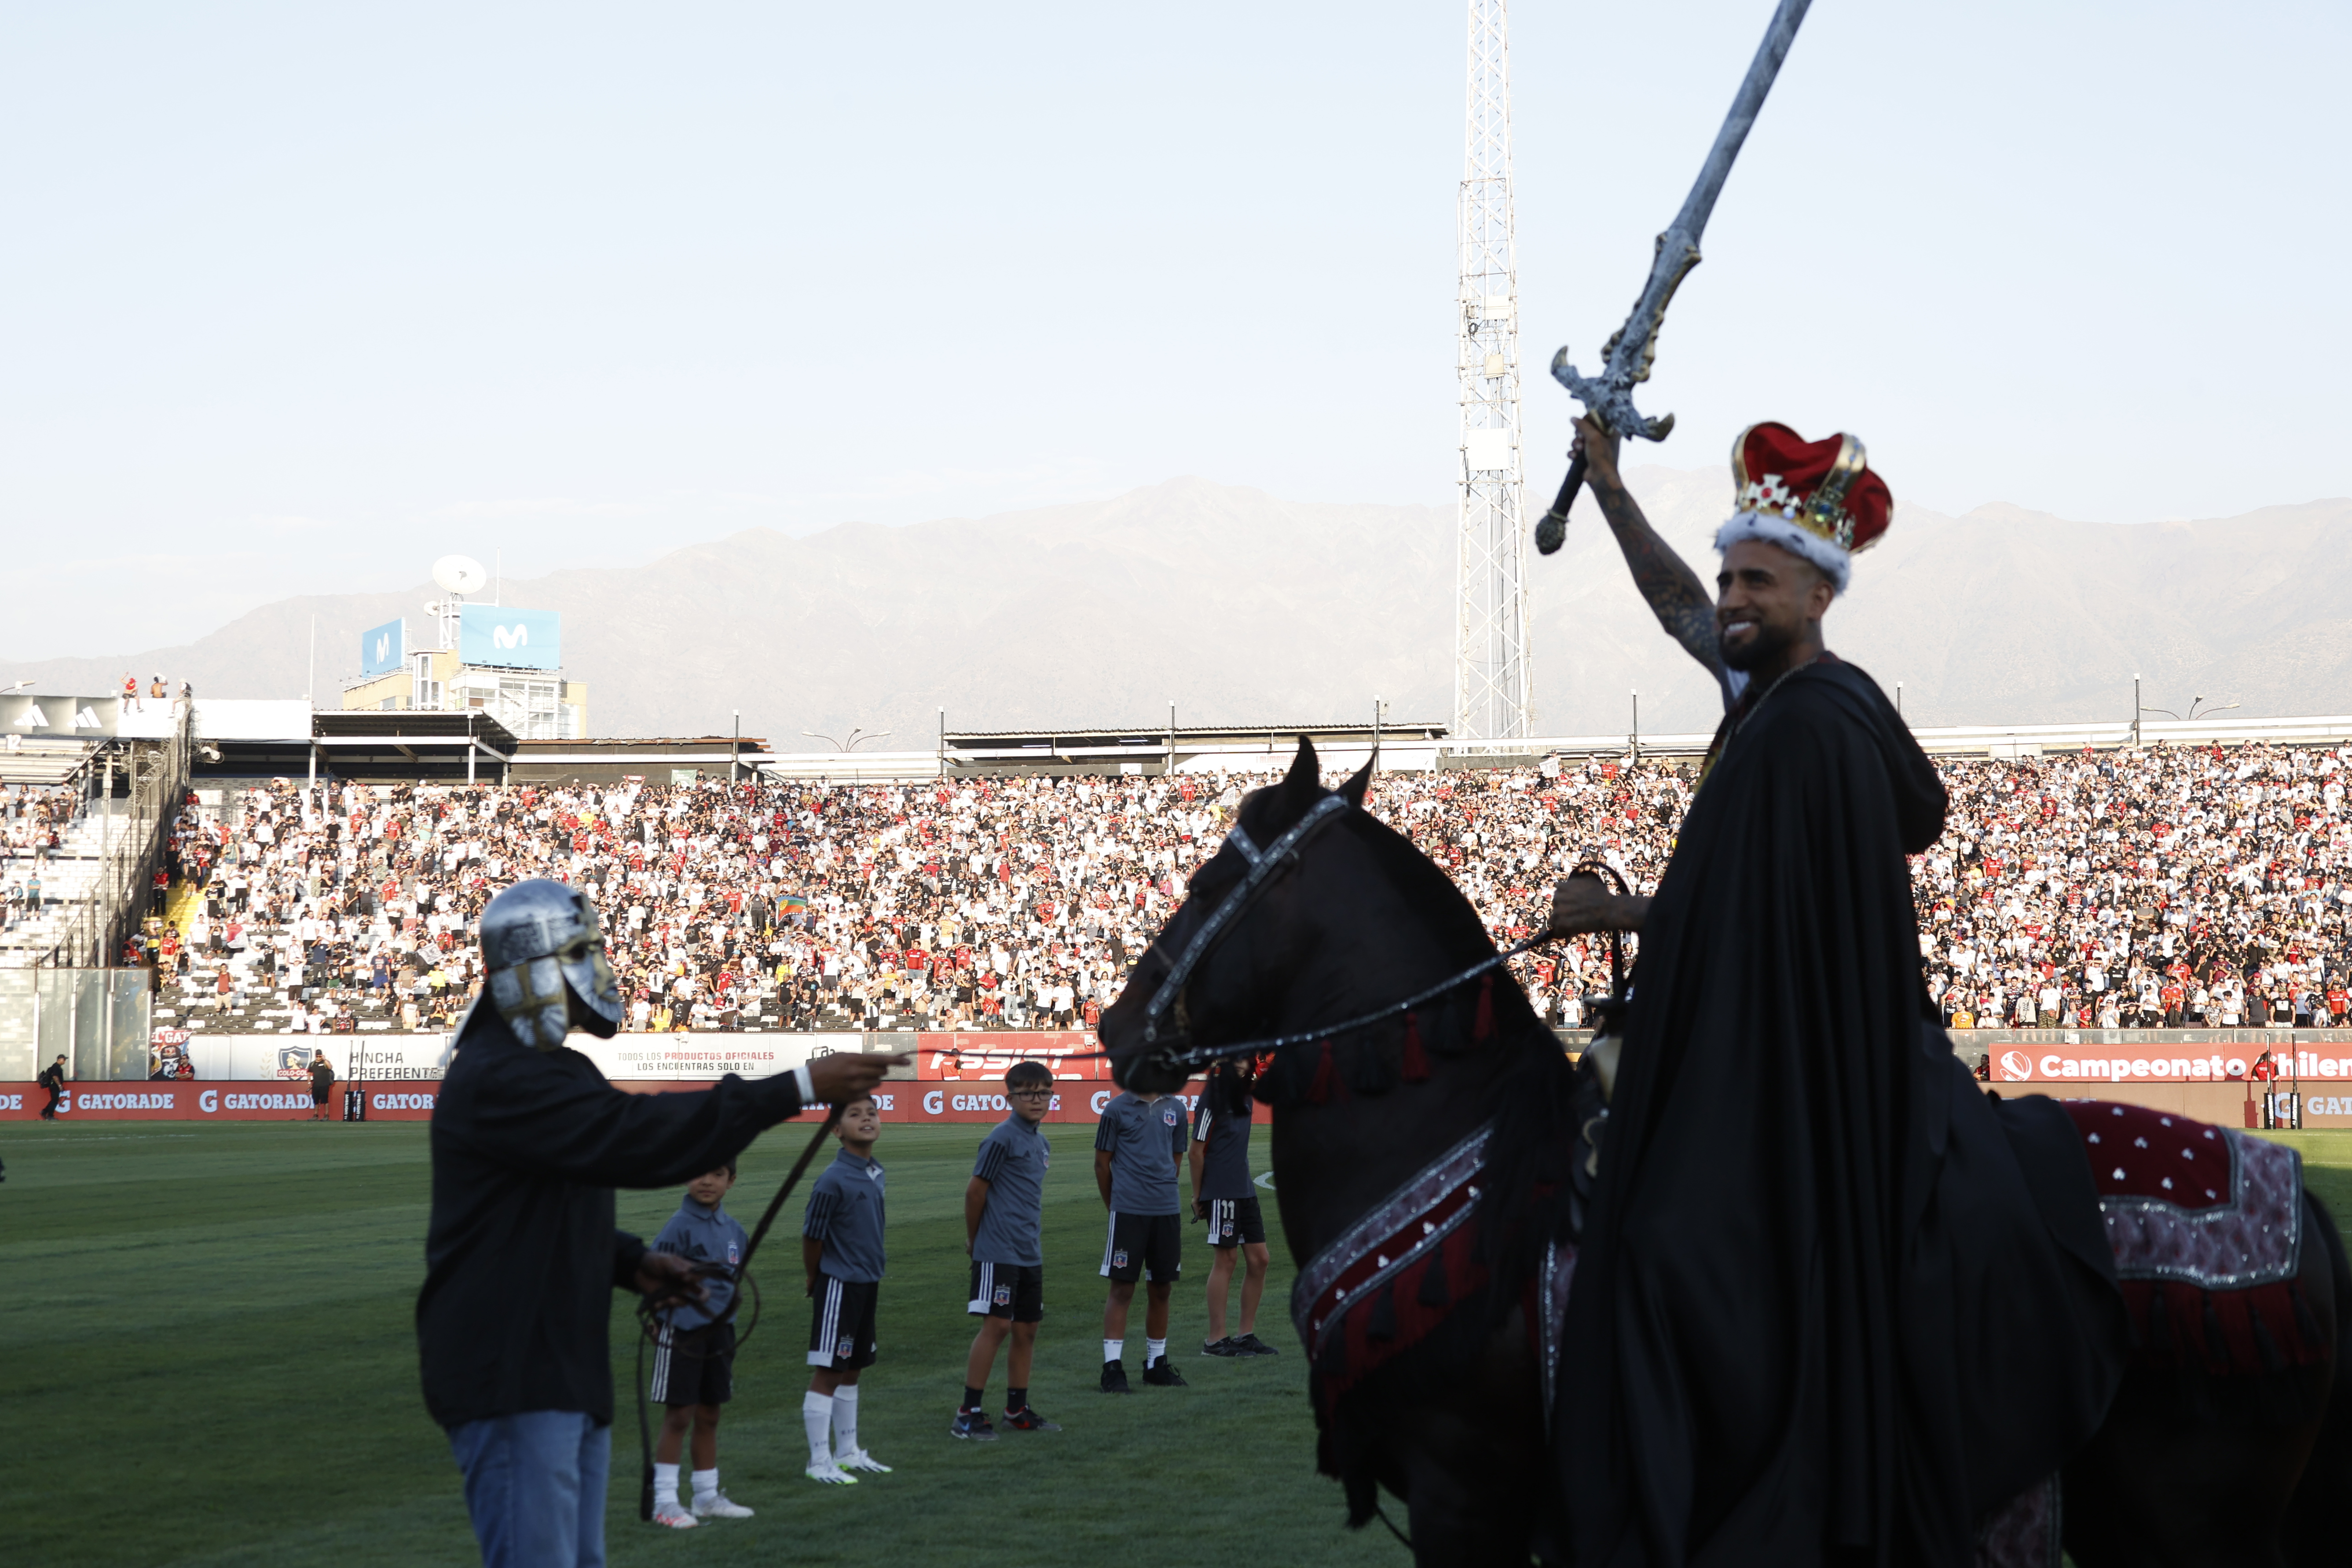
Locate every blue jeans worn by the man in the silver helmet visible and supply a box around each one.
[449,1410,612,1568]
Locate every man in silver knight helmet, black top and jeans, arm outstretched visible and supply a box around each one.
[416,879,905,1568]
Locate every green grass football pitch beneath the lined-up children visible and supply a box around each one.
[0,1121,2352,1568]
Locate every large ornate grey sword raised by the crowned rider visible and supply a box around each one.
[1536,0,1813,555]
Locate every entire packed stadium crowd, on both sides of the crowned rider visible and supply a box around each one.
[132,747,2352,1032]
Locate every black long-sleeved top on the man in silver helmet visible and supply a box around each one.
[416,1004,818,1427]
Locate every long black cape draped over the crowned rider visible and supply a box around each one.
[1557,660,2124,1568]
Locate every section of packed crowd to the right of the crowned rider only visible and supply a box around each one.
[1912,745,2352,1029]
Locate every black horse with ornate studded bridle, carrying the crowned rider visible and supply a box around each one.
[1101,740,2352,1568]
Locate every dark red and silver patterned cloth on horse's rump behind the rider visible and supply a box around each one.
[2060,1100,2326,1375]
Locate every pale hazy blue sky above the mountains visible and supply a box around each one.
[0,0,2352,675]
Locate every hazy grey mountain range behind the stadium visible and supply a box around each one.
[5,468,2352,750]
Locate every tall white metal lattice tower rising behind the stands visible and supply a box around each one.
[1454,0,1534,740]
